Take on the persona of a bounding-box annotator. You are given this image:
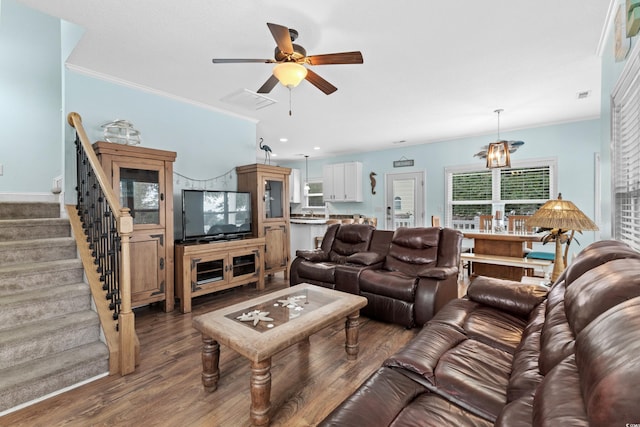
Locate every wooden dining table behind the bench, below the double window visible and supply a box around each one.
[464,231,542,281]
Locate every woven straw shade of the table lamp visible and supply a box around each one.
[527,194,598,231]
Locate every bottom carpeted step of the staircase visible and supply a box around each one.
[0,341,109,411]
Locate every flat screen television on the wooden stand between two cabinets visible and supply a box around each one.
[182,190,252,241]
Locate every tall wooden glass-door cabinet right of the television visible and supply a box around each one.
[236,164,291,280]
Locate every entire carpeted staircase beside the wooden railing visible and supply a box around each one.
[0,202,109,414]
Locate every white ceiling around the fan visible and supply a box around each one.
[19,0,615,162]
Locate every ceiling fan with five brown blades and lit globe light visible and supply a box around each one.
[213,23,363,95]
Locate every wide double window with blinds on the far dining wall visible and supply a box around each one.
[445,159,556,229]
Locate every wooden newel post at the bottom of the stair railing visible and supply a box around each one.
[118,208,136,375]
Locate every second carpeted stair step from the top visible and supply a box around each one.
[0,218,71,241]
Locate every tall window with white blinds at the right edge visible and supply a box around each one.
[611,40,640,250]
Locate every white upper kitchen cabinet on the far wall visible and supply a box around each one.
[322,162,362,202]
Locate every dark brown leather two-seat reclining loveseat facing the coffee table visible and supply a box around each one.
[290,224,462,328]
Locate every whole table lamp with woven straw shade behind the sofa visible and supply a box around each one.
[527,194,598,282]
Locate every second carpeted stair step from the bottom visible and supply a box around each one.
[0,310,100,370]
